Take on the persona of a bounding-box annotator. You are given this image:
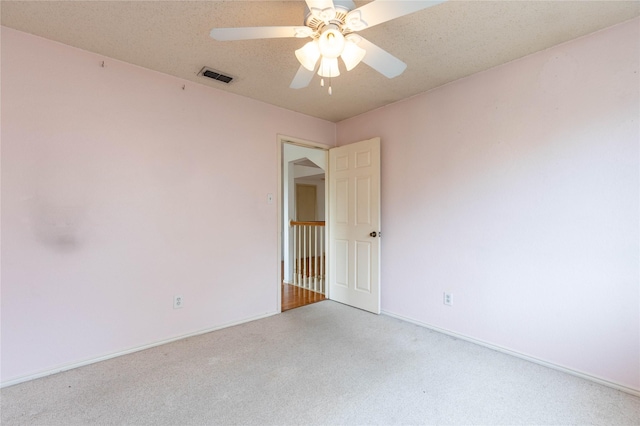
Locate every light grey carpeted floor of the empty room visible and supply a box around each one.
[0,301,640,425]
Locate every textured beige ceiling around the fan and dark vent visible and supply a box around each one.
[0,0,640,122]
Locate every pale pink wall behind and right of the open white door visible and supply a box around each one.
[337,19,640,390]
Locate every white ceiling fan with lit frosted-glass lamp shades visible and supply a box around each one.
[210,0,445,94]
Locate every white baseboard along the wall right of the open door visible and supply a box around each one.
[382,311,640,396]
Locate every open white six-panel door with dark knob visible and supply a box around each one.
[329,138,380,314]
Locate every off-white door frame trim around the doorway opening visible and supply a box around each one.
[276,134,336,313]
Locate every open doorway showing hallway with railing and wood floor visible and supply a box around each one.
[279,139,328,311]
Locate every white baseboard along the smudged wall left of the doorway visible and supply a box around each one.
[0,312,279,388]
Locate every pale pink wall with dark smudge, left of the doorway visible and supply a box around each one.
[1,27,335,383]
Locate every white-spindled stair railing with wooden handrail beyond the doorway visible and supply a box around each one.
[290,220,325,294]
